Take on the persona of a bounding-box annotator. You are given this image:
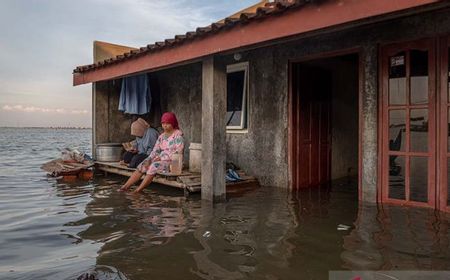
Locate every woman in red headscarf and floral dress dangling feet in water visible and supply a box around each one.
[120,112,184,193]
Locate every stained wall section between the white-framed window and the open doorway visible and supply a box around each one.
[224,48,288,187]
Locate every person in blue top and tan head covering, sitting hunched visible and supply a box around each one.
[123,118,159,168]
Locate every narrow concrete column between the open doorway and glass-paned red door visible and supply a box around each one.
[360,44,379,203]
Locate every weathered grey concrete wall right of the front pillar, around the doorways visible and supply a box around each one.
[221,7,450,202]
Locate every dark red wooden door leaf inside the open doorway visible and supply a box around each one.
[291,63,332,188]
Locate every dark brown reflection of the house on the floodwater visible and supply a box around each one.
[60,176,450,279]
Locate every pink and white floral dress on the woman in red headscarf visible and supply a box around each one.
[137,129,184,175]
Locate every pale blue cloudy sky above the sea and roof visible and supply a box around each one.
[0,0,258,127]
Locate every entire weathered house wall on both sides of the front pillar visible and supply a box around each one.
[92,7,450,202]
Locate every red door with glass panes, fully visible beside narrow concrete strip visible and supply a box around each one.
[381,39,436,207]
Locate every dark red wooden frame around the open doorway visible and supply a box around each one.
[287,46,365,195]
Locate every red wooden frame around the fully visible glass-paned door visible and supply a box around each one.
[378,38,439,208]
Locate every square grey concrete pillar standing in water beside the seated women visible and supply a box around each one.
[202,57,227,201]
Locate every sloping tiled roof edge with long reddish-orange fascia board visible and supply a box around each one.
[73,0,441,85]
